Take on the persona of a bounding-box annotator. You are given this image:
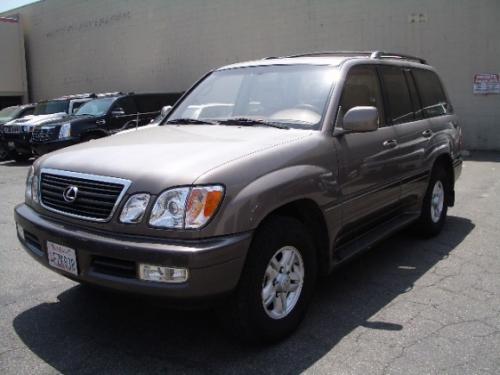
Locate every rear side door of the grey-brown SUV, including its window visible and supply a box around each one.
[378,65,432,204]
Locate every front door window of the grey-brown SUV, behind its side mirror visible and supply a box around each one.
[340,66,385,126]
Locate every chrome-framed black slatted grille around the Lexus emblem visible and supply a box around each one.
[40,170,130,221]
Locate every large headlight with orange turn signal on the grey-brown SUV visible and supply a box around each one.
[149,185,224,229]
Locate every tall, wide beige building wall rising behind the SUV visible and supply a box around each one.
[3,0,500,150]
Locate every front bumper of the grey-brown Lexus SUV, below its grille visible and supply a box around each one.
[15,204,252,301]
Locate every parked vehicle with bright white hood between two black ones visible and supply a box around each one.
[2,94,97,161]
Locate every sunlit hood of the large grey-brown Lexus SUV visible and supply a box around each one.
[38,125,314,193]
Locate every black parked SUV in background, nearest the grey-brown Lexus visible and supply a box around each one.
[31,93,181,155]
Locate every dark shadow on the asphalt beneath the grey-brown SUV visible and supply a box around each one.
[13,216,475,374]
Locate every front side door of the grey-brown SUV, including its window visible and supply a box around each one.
[337,65,400,237]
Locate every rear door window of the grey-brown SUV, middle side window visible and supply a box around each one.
[380,66,415,124]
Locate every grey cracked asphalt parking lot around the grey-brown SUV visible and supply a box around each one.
[0,153,500,374]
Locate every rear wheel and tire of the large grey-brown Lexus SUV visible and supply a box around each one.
[417,166,452,237]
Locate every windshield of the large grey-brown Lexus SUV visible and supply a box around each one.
[167,65,335,129]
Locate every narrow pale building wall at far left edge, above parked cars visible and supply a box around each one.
[0,20,27,101]
